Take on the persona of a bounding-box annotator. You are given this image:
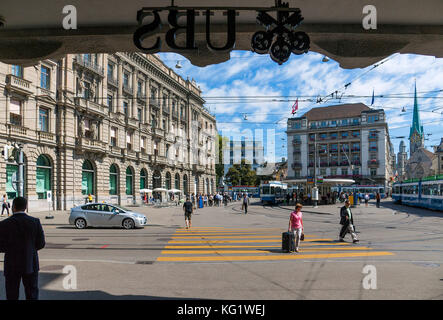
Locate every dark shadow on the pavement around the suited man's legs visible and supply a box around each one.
[0,271,200,300]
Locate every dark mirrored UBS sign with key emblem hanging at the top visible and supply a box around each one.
[133,0,310,64]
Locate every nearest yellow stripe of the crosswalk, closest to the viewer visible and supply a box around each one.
[157,251,394,262]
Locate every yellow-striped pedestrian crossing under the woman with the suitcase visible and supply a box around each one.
[157,227,393,262]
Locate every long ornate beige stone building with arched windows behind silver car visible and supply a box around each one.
[0,53,217,211]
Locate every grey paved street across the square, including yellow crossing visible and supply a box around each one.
[0,201,443,299]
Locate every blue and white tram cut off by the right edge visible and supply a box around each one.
[392,176,443,211]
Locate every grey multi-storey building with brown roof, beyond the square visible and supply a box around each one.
[286,103,395,186]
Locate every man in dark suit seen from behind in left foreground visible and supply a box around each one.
[0,197,45,300]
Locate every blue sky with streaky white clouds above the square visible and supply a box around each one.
[159,51,443,161]
